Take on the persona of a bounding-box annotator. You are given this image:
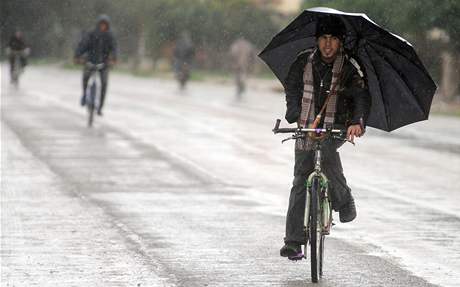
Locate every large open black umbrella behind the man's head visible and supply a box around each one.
[259,8,436,131]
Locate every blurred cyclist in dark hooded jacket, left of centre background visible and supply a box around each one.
[74,15,117,116]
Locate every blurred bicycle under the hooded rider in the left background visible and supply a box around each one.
[85,62,106,127]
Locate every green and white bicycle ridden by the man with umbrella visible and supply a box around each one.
[273,119,354,283]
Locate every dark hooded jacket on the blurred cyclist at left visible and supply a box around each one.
[75,16,117,64]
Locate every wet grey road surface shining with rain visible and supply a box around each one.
[1,67,460,286]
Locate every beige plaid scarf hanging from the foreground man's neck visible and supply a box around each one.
[296,50,345,151]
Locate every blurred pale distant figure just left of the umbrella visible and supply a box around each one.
[230,38,256,99]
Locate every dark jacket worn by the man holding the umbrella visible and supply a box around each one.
[284,51,370,129]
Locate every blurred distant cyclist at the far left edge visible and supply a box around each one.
[6,30,30,84]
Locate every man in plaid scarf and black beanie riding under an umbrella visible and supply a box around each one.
[280,16,370,257]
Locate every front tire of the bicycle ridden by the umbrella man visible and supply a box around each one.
[309,177,321,283]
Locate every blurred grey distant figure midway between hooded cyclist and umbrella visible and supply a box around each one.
[173,31,195,90]
